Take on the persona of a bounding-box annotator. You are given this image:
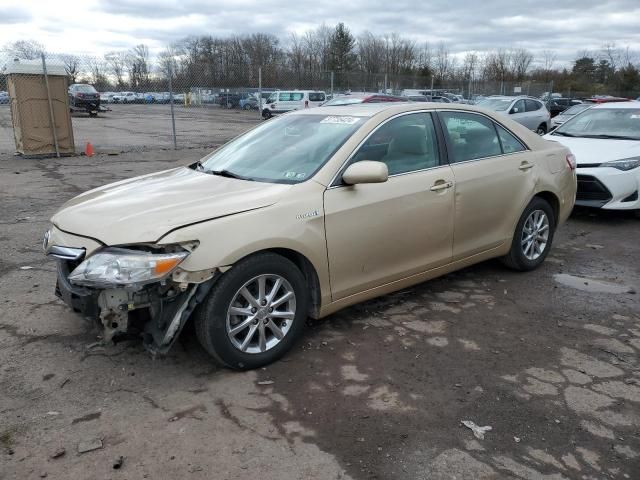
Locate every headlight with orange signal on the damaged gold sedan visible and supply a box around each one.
[69,248,189,288]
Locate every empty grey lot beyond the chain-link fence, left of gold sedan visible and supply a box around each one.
[0,105,260,153]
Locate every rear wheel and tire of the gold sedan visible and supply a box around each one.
[502,197,556,272]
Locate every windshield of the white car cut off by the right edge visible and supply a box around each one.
[553,108,640,140]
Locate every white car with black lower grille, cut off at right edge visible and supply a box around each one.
[544,102,640,211]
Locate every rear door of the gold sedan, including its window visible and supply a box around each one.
[438,111,538,261]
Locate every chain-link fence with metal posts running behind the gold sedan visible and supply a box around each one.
[0,54,632,158]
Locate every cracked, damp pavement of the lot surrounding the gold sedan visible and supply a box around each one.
[0,148,640,479]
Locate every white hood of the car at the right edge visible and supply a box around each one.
[544,134,640,165]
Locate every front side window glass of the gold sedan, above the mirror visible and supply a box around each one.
[353,113,439,175]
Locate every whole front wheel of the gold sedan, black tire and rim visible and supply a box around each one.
[194,253,308,370]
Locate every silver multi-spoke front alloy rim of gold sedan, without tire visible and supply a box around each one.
[226,274,296,353]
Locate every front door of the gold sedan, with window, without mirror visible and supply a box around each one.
[324,112,453,301]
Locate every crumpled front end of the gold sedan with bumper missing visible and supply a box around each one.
[43,227,220,354]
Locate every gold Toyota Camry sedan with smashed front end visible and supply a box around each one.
[44,103,576,369]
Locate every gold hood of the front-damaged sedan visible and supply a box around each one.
[51,167,291,245]
